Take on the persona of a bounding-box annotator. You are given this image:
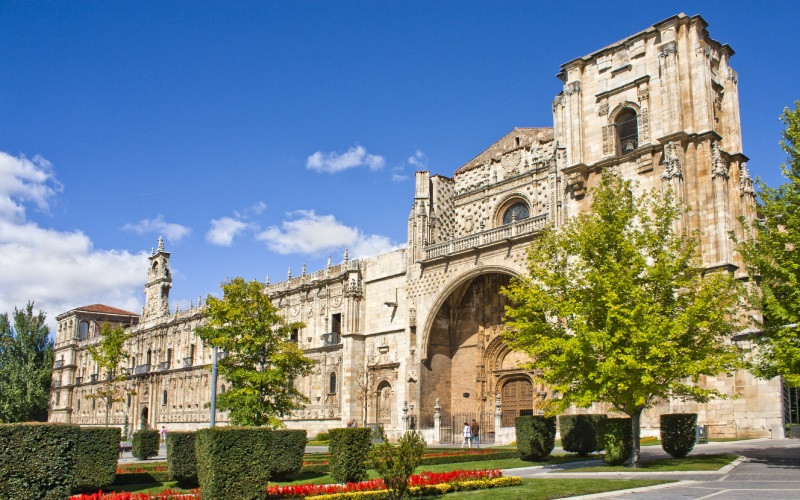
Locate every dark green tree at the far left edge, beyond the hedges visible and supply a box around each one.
[0,302,53,422]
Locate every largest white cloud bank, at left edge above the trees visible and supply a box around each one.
[0,152,147,328]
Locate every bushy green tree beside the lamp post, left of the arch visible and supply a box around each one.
[195,278,313,427]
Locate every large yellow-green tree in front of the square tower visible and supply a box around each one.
[504,174,742,467]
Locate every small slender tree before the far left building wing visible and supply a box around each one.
[87,324,133,427]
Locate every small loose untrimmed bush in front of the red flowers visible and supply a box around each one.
[370,431,425,500]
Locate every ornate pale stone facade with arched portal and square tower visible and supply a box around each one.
[52,14,783,442]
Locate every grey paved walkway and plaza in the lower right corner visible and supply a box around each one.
[503,439,800,500]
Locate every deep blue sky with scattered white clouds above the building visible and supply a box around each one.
[0,1,800,326]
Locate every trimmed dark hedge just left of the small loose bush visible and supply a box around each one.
[328,427,372,483]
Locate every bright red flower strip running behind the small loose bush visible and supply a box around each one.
[266,469,503,500]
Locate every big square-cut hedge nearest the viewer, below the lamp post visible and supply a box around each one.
[195,427,273,500]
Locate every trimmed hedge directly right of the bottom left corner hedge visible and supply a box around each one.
[72,427,121,491]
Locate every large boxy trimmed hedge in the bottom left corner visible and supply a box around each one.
[0,422,80,500]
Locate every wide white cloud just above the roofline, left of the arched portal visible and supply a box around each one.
[256,210,400,258]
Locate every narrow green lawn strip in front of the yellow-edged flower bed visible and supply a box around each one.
[428,479,674,500]
